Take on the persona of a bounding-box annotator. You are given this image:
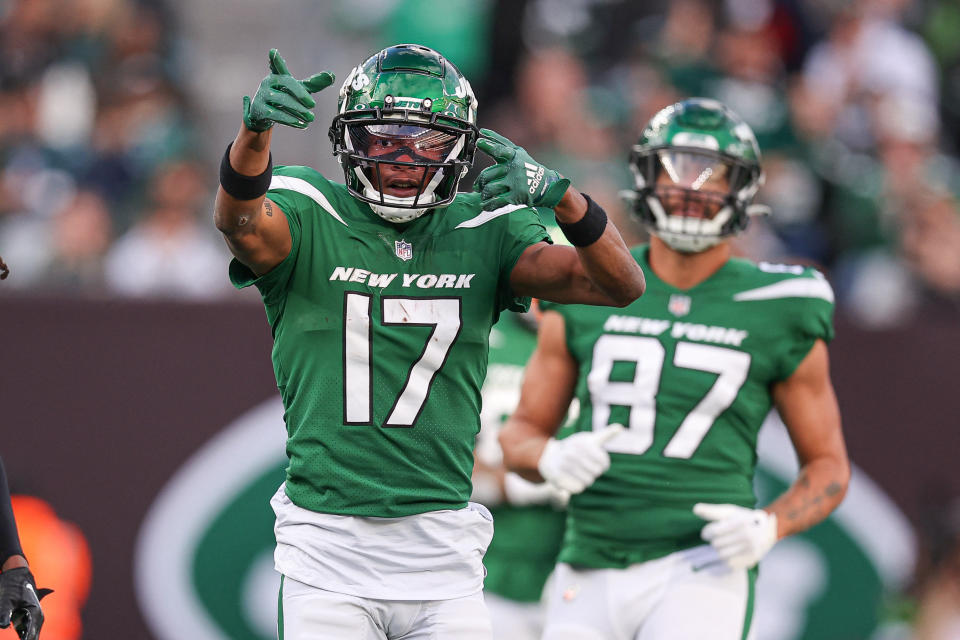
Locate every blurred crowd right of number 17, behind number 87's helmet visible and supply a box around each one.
[480,0,960,327]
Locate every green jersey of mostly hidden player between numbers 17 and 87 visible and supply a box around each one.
[477,313,566,602]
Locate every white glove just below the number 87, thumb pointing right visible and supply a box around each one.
[537,424,623,494]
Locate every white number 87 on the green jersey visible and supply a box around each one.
[587,334,750,458]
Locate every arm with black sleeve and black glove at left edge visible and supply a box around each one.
[0,459,50,640]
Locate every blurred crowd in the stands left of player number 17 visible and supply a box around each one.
[0,0,229,298]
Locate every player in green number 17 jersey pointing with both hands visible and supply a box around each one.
[215,45,644,640]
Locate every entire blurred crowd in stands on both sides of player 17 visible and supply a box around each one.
[0,0,960,318]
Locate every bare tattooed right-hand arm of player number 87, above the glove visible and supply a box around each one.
[765,340,850,538]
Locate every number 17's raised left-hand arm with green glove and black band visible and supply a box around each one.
[214,49,333,275]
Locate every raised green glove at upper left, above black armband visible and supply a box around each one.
[243,49,334,131]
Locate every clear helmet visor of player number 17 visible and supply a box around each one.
[347,123,461,163]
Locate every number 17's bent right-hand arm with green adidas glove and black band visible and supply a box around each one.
[473,129,646,307]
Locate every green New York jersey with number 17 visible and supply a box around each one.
[230,162,549,517]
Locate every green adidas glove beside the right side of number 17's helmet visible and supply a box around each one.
[473,129,570,211]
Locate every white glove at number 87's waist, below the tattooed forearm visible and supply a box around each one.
[693,502,777,569]
